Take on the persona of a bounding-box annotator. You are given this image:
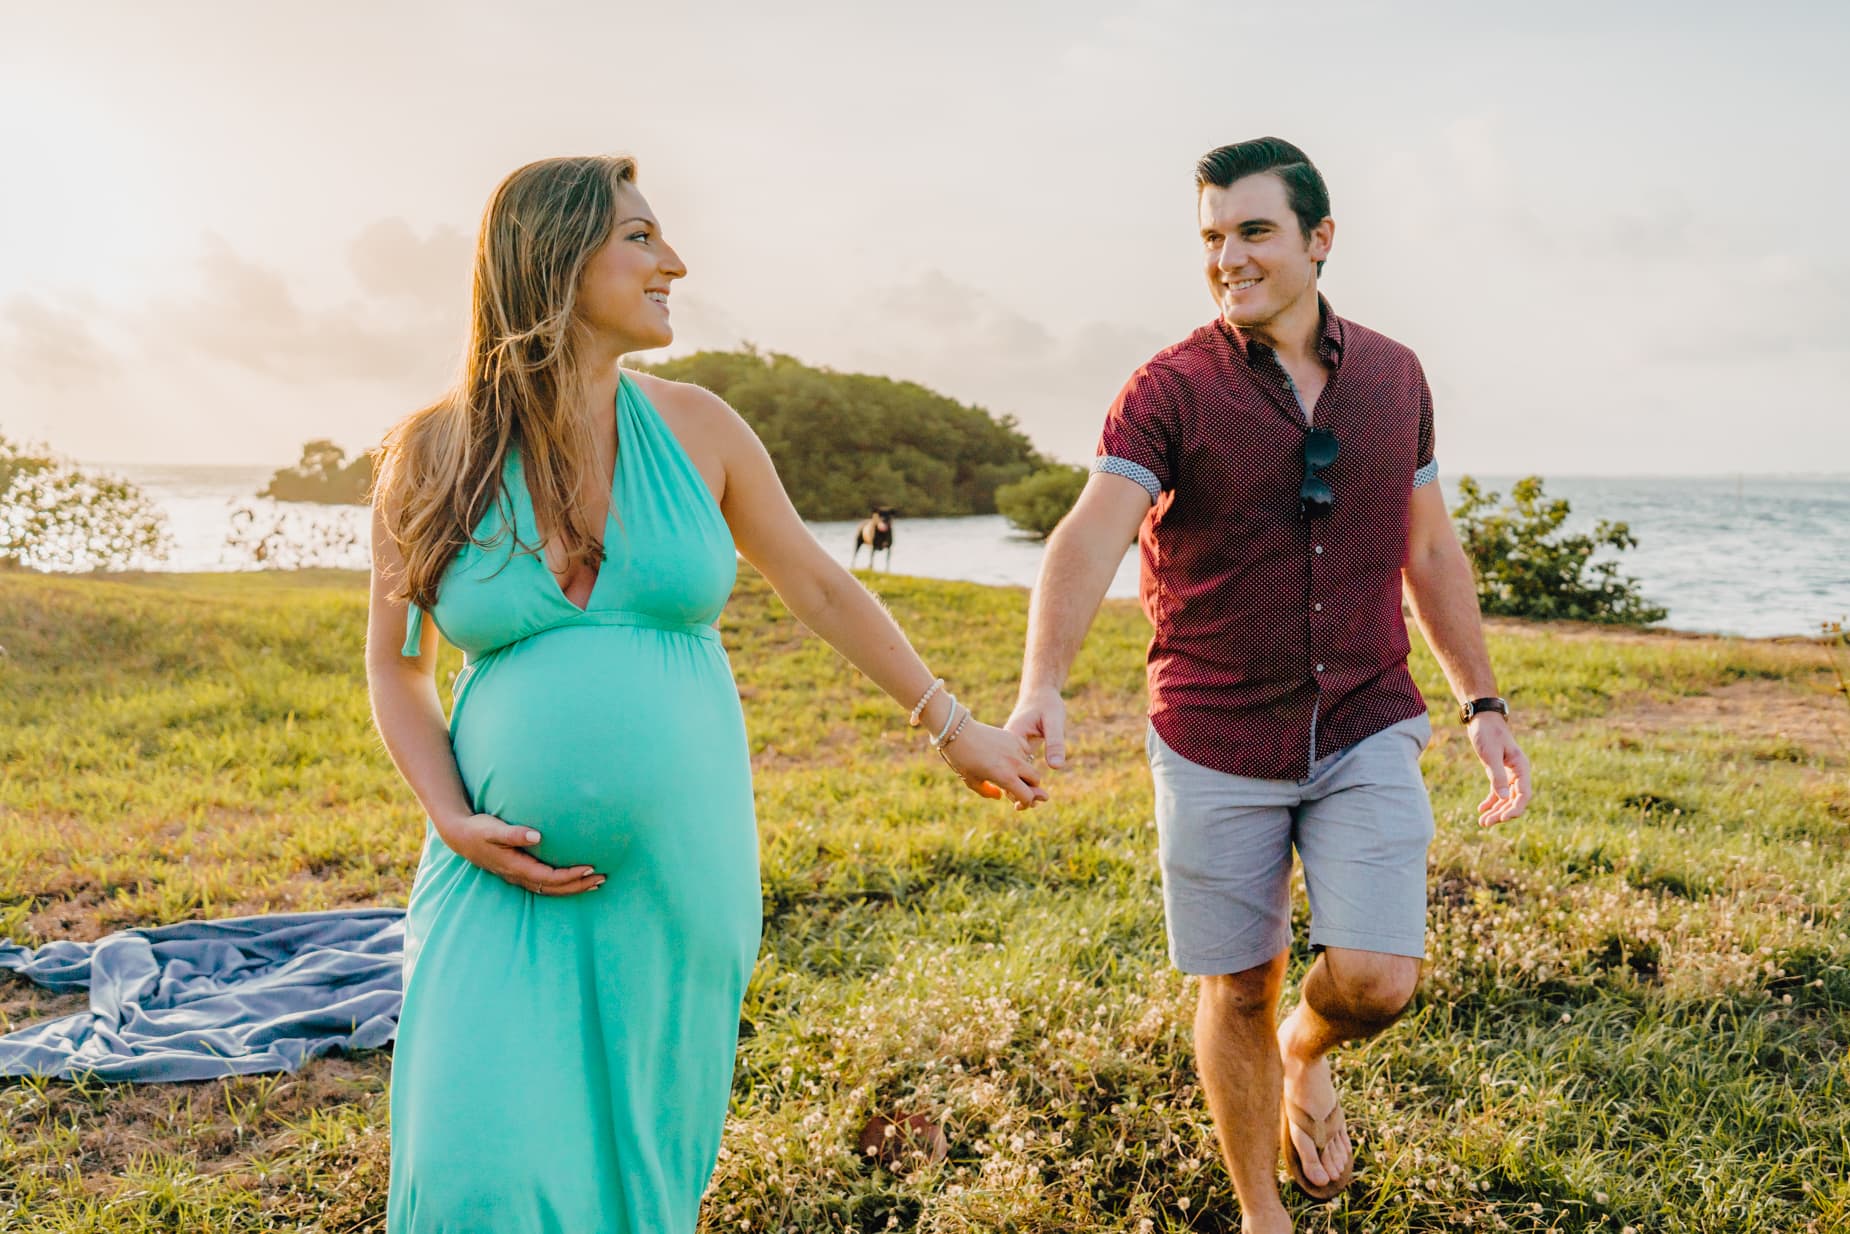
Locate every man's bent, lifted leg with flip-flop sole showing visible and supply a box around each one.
[1273,947,1419,1186]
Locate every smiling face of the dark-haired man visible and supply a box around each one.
[1197,172,1336,327]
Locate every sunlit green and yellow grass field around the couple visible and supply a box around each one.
[0,572,1850,1234]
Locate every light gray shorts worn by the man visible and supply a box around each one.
[1145,716,1432,973]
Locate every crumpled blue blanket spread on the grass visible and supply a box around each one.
[0,908,405,1080]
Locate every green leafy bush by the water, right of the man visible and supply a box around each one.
[1452,475,1669,625]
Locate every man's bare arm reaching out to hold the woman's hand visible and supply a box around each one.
[1003,472,1151,768]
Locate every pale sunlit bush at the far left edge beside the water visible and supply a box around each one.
[0,437,167,570]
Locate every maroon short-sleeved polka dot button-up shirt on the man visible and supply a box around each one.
[1093,302,1437,779]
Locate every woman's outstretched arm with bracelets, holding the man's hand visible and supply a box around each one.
[670,385,1047,808]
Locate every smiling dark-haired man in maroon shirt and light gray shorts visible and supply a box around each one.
[1008,137,1530,1234]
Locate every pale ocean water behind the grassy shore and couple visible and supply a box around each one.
[83,464,1850,636]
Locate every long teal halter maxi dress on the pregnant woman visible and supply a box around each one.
[387,376,760,1234]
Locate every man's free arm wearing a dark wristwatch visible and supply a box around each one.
[1400,483,1534,827]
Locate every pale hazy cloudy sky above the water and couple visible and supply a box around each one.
[0,0,1850,475]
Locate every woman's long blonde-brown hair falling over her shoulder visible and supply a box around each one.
[374,157,636,609]
